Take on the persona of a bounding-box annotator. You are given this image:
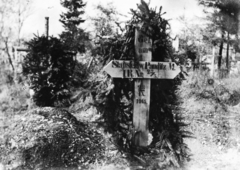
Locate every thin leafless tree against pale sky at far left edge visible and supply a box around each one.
[0,0,32,71]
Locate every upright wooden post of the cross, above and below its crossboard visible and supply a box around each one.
[133,28,152,146]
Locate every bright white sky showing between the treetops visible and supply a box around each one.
[21,0,203,37]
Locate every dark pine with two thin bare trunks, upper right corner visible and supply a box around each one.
[199,0,240,69]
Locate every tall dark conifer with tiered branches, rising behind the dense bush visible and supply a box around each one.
[60,0,88,53]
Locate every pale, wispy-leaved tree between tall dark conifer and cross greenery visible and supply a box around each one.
[90,3,123,69]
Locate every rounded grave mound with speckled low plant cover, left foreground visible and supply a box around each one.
[1,107,105,170]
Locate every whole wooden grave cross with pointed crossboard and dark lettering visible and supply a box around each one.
[104,26,180,146]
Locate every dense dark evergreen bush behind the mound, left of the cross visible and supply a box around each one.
[23,36,76,106]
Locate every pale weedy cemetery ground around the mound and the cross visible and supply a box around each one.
[0,70,240,170]
